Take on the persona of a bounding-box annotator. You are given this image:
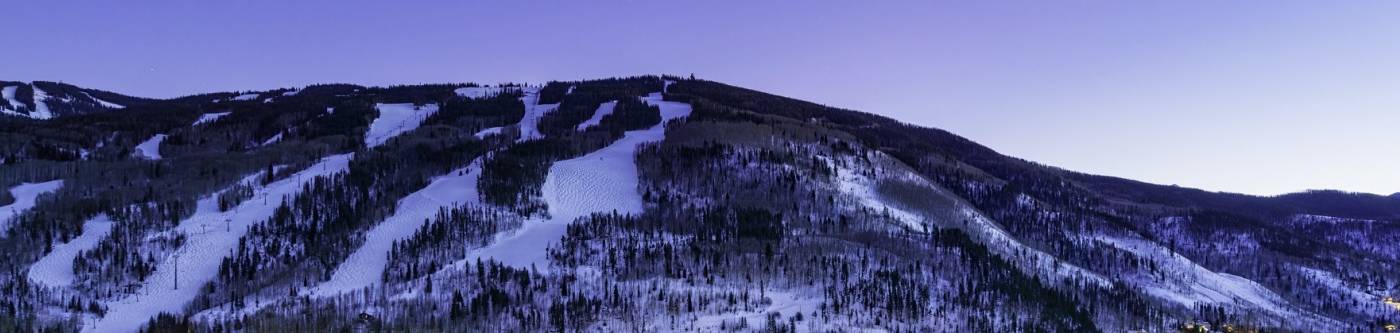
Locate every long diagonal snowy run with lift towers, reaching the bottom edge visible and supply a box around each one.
[83,154,351,332]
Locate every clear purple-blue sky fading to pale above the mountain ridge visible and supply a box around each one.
[0,0,1400,194]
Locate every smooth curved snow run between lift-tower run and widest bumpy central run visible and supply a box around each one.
[312,160,482,295]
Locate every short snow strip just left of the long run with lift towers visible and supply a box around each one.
[29,214,112,287]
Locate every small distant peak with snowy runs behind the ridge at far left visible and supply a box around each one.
[0,81,150,119]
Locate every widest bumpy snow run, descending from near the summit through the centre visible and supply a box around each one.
[466,92,690,270]
